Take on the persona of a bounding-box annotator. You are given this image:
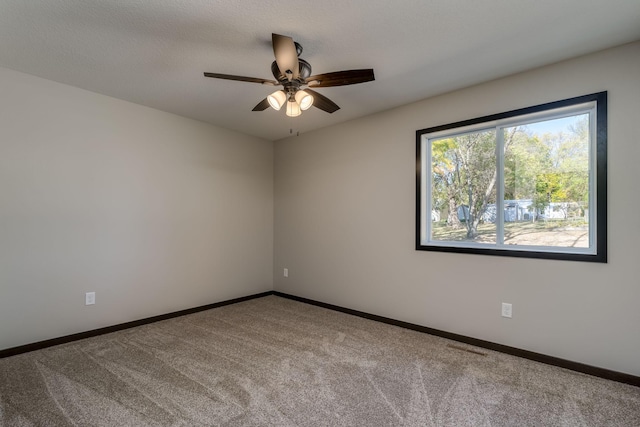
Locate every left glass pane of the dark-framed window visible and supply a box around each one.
[430,129,496,244]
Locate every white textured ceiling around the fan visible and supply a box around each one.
[0,0,640,140]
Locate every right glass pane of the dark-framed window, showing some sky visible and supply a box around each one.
[502,114,590,248]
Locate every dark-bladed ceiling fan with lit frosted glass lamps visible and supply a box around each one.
[204,34,374,117]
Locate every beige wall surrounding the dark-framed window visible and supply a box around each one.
[274,43,640,375]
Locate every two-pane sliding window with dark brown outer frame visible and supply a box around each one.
[416,92,607,262]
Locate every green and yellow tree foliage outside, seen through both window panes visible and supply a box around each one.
[431,115,589,238]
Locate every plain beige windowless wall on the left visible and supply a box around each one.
[0,69,273,349]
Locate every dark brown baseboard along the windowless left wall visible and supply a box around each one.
[0,291,273,359]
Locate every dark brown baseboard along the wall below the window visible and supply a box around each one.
[272,291,640,387]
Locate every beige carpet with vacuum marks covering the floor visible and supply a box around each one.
[0,296,640,427]
